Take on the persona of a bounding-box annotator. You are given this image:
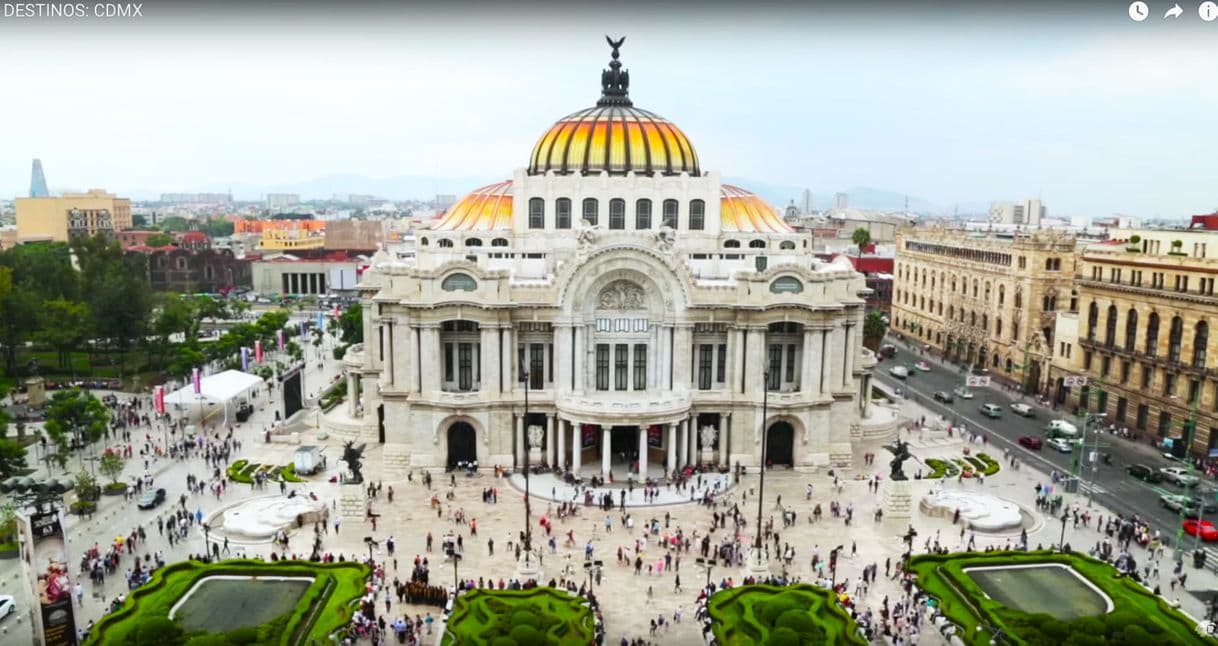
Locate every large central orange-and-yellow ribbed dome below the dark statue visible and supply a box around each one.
[529,105,702,176]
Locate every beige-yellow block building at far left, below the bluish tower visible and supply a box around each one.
[16,189,132,243]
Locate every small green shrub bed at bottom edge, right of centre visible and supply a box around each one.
[708,584,866,646]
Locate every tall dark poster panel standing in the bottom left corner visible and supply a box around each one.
[18,511,78,646]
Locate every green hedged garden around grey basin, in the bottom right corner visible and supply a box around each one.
[910,551,1218,646]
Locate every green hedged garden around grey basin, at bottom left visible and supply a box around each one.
[85,559,369,646]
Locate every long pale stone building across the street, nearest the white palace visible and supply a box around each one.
[892,228,1075,392]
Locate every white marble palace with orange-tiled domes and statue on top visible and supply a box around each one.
[335,43,875,478]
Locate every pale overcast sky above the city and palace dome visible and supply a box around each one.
[0,0,1218,217]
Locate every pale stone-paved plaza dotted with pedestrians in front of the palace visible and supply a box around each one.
[0,336,1214,644]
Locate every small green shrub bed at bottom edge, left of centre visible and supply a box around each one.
[441,587,596,646]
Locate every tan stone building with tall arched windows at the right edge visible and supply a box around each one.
[1055,229,1218,455]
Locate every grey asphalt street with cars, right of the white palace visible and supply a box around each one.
[876,344,1218,575]
